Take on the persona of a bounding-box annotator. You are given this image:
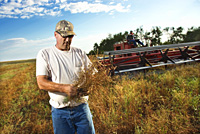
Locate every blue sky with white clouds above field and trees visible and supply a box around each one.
[0,0,200,61]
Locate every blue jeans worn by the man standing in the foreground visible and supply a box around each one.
[52,103,95,134]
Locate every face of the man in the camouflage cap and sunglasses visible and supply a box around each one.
[54,32,73,51]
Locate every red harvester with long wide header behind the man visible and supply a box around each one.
[98,41,200,74]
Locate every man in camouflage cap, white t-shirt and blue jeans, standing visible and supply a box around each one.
[36,20,95,134]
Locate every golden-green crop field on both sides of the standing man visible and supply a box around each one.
[0,60,200,134]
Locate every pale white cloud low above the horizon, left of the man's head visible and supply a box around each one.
[0,37,55,61]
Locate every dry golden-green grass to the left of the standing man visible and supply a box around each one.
[0,62,53,134]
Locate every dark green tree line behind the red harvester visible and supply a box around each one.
[89,26,200,55]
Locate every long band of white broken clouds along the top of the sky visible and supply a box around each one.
[0,0,129,18]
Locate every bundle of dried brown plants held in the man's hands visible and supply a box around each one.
[65,61,113,99]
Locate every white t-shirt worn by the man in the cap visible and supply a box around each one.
[36,46,91,108]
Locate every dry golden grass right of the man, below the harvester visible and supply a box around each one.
[90,63,200,134]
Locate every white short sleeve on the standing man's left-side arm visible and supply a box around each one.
[36,50,48,76]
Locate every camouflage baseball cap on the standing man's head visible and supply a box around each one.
[55,20,76,36]
